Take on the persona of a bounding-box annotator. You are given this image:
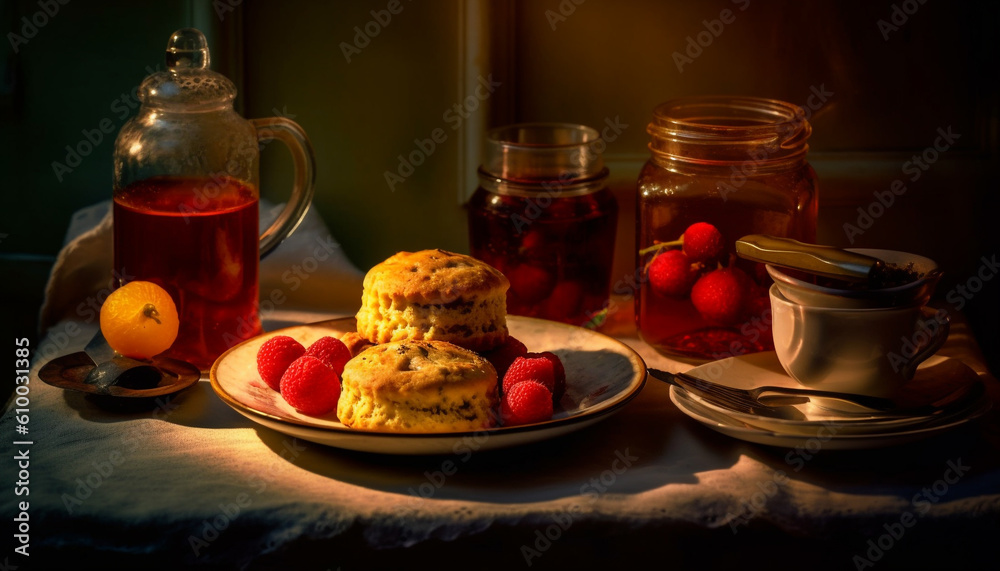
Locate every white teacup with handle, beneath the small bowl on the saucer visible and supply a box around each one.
[770,285,950,397]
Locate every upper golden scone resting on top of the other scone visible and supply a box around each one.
[357,250,510,351]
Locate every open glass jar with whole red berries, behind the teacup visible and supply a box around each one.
[636,96,817,359]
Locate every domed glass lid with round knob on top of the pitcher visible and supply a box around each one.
[139,28,236,111]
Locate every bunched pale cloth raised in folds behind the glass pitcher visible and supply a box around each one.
[39,200,364,334]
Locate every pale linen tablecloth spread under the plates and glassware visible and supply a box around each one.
[0,203,1000,570]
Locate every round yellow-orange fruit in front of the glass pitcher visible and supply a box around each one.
[101,281,180,359]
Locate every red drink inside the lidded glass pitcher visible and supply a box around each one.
[114,177,261,370]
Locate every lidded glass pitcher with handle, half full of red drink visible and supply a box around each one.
[113,28,315,370]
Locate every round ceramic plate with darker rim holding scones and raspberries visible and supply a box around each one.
[210,316,646,454]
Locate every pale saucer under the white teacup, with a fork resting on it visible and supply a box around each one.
[670,352,992,449]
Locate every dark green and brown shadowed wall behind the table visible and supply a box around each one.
[0,0,1000,394]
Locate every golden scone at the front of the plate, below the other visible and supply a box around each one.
[337,340,498,433]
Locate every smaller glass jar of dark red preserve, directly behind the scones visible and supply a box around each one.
[469,123,618,325]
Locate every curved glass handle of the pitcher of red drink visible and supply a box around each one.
[250,117,316,259]
